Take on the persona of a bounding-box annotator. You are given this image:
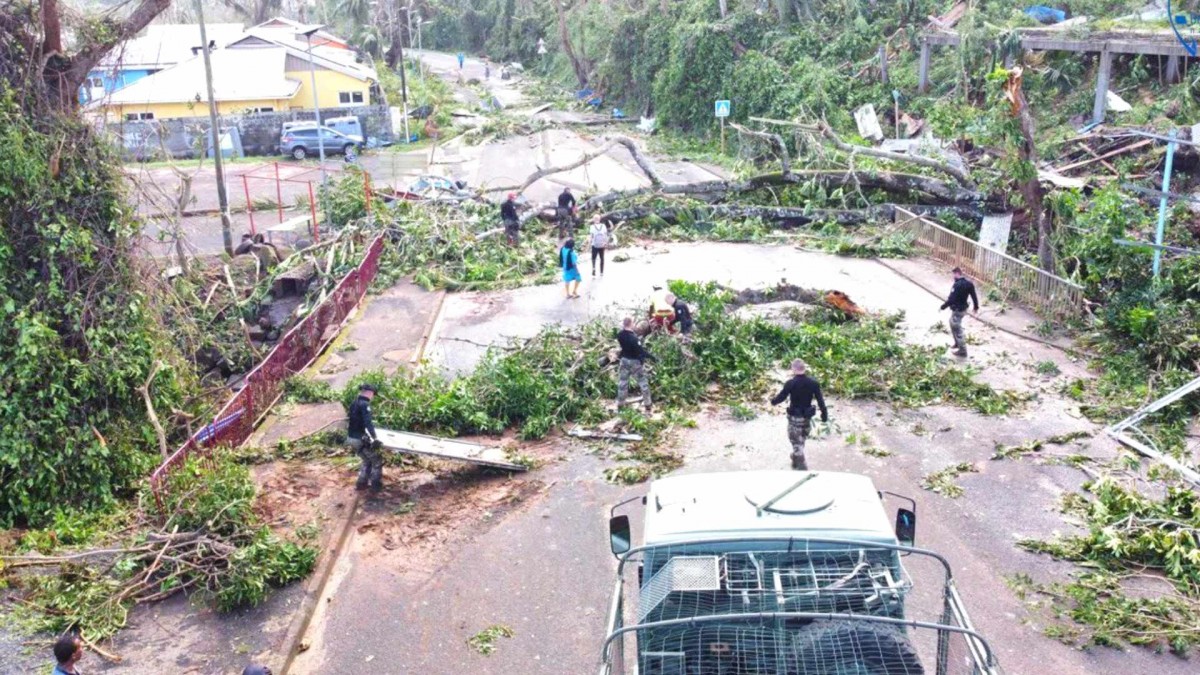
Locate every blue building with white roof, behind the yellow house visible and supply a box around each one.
[79,24,244,103]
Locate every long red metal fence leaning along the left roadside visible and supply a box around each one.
[150,235,383,501]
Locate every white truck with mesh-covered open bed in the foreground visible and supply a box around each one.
[599,471,1002,675]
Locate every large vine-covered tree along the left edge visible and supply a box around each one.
[0,0,186,525]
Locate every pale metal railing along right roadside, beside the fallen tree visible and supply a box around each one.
[894,207,1084,319]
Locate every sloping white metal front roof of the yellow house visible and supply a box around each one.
[92,48,300,106]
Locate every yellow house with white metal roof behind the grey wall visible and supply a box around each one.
[89,29,376,121]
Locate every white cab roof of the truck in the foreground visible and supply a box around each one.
[643,471,896,546]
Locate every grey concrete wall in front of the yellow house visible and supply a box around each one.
[104,106,392,160]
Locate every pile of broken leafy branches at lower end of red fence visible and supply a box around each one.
[10,454,317,640]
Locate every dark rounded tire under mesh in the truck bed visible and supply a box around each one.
[793,621,925,675]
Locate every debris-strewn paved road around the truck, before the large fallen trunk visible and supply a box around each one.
[295,244,1195,675]
